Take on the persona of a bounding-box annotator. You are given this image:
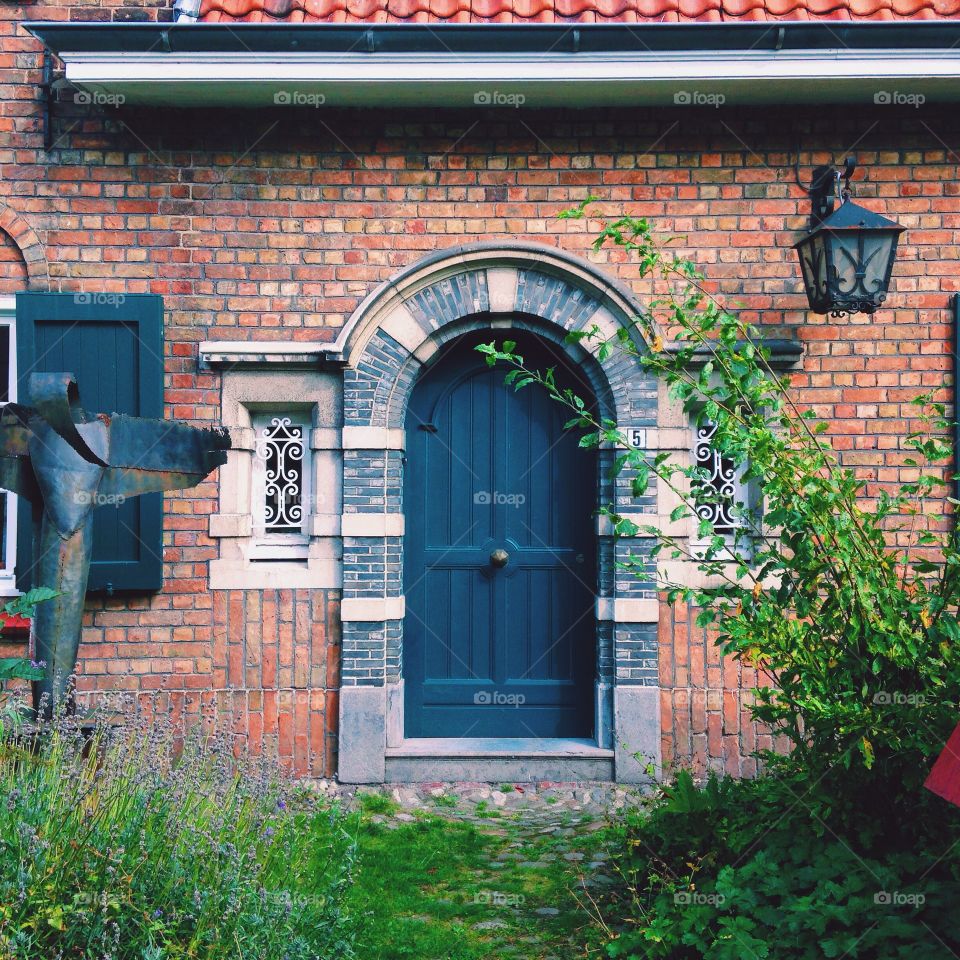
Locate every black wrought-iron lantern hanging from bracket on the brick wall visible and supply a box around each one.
[794,157,906,317]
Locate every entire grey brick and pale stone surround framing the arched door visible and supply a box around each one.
[337,242,659,782]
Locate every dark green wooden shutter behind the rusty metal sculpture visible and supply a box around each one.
[17,293,163,593]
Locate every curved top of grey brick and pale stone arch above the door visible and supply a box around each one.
[338,242,637,428]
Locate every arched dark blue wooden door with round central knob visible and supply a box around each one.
[404,334,596,737]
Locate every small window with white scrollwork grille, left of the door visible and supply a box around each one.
[251,413,311,559]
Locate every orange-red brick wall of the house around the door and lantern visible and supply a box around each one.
[0,3,960,773]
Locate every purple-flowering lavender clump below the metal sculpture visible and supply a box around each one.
[0,717,354,960]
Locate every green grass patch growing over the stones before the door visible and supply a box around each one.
[350,794,605,960]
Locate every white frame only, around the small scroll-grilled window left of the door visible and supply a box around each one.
[250,409,314,560]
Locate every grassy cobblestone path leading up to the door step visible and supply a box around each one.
[319,783,643,960]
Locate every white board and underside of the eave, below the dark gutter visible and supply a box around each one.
[60,49,960,111]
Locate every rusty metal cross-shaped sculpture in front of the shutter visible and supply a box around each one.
[0,373,230,714]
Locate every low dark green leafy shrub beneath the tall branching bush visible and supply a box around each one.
[608,773,960,960]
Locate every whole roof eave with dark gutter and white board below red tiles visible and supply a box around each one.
[25,20,960,108]
